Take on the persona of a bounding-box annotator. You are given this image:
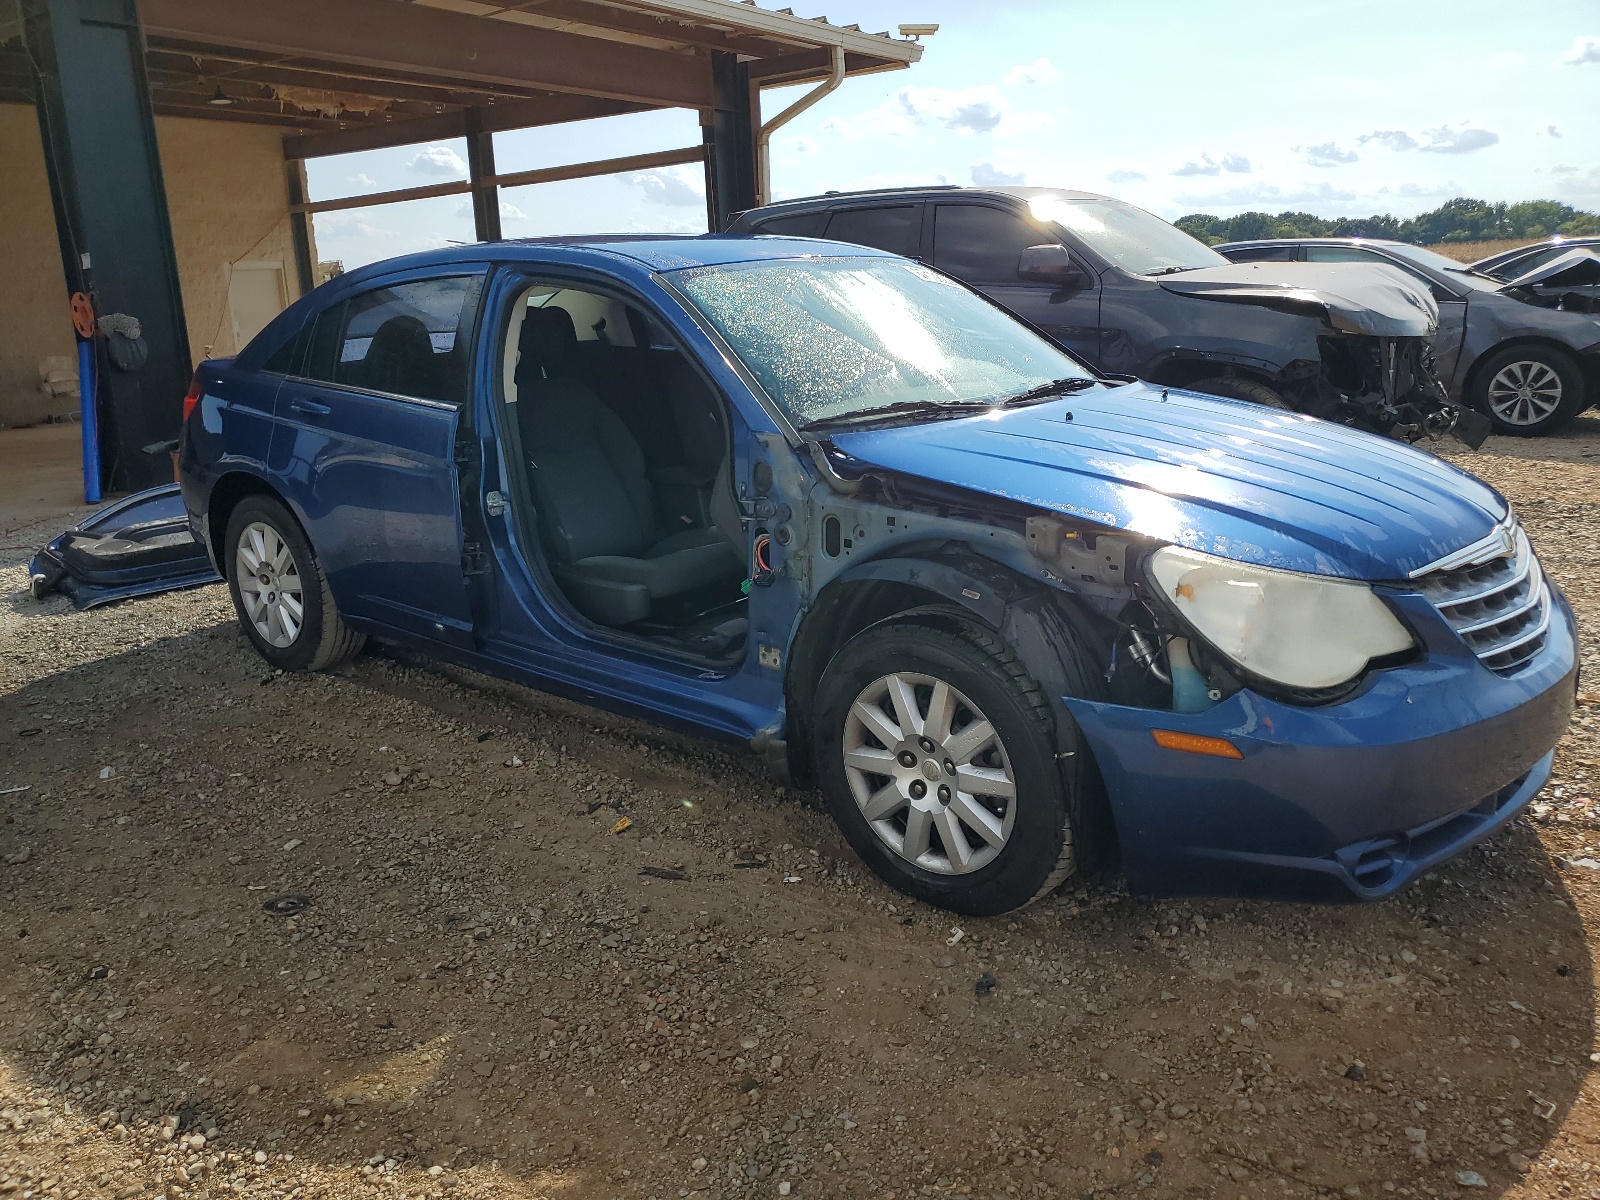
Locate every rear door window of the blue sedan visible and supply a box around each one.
[306,275,482,405]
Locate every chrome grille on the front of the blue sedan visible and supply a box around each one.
[1413,518,1550,675]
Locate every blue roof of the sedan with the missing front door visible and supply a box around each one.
[318,234,894,292]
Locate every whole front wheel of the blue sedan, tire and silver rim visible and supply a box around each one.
[816,613,1078,915]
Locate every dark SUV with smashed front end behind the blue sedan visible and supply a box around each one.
[728,187,1488,445]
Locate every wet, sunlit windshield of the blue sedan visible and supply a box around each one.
[670,258,1094,426]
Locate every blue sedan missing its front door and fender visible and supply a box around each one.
[179,237,1578,914]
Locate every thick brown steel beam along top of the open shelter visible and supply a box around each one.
[141,0,710,109]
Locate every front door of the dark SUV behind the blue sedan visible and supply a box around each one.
[933,205,1101,366]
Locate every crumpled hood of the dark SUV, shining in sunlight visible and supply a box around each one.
[1158,262,1438,338]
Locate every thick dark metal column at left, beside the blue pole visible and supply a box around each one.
[22,0,190,490]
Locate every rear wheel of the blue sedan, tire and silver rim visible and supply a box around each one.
[221,496,366,670]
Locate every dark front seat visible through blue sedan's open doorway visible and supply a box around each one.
[517,309,744,626]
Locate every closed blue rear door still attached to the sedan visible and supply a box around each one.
[272,267,485,646]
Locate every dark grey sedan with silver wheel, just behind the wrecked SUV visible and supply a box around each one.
[1216,237,1600,437]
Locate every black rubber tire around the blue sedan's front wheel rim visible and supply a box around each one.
[814,610,1083,917]
